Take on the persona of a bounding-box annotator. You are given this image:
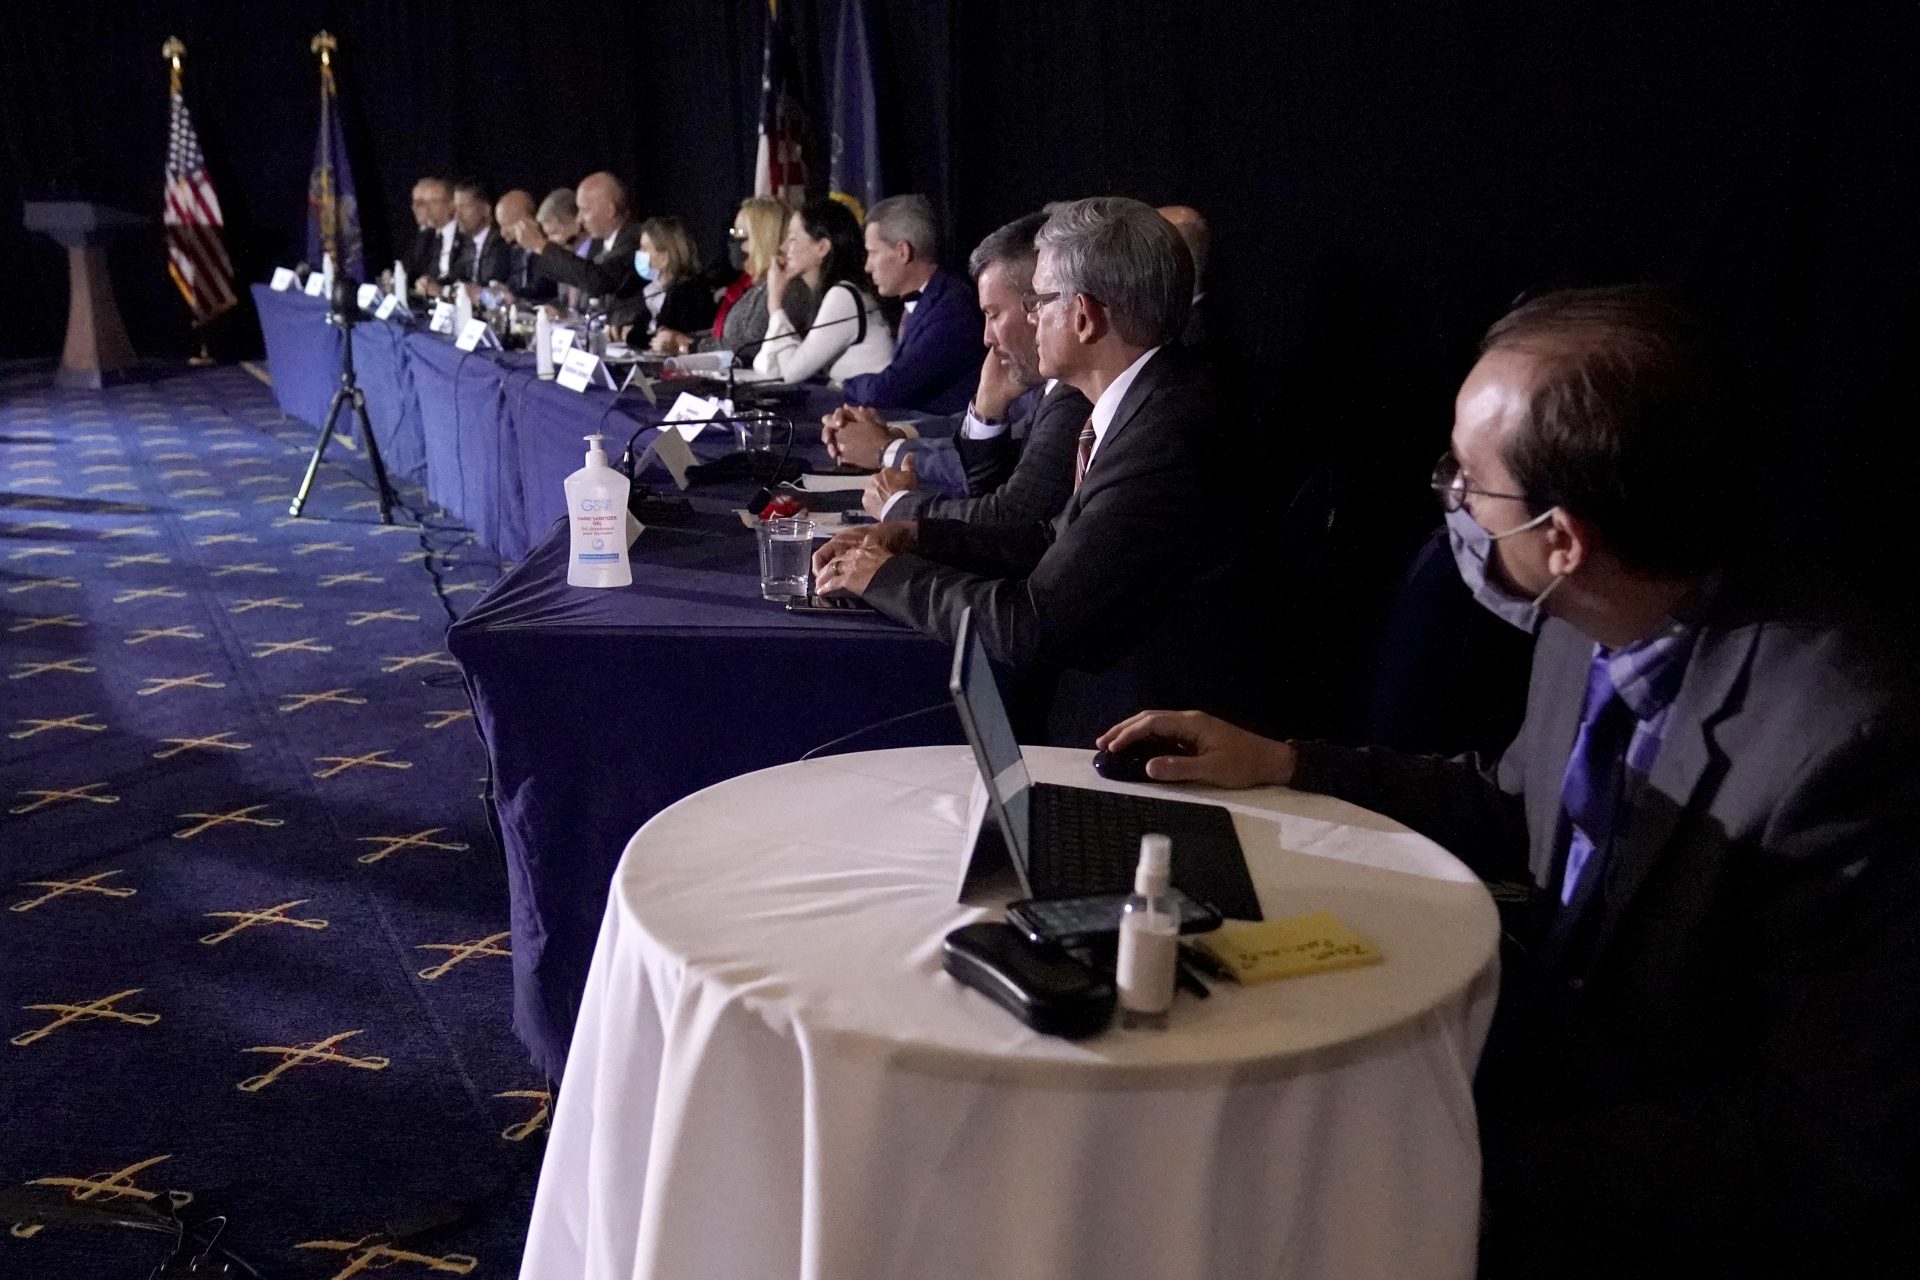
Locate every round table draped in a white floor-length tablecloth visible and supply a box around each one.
[520,747,1498,1280]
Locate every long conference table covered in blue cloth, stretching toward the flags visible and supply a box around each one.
[253,286,958,1080]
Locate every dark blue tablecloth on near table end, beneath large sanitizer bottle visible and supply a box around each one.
[447,503,960,1079]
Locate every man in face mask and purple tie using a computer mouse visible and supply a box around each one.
[1100,288,1920,1278]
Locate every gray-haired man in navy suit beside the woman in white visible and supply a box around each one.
[843,196,979,413]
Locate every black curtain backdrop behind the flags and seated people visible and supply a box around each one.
[0,0,1920,579]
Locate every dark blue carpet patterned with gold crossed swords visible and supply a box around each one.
[0,367,547,1280]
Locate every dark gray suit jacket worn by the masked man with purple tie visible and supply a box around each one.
[1296,587,1920,1276]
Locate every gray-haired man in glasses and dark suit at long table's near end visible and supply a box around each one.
[814,198,1254,747]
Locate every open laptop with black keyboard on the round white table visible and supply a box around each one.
[948,610,1261,919]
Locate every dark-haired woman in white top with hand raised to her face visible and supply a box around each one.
[753,200,893,382]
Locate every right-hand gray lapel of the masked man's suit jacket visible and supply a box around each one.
[1594,626,1759,956]
